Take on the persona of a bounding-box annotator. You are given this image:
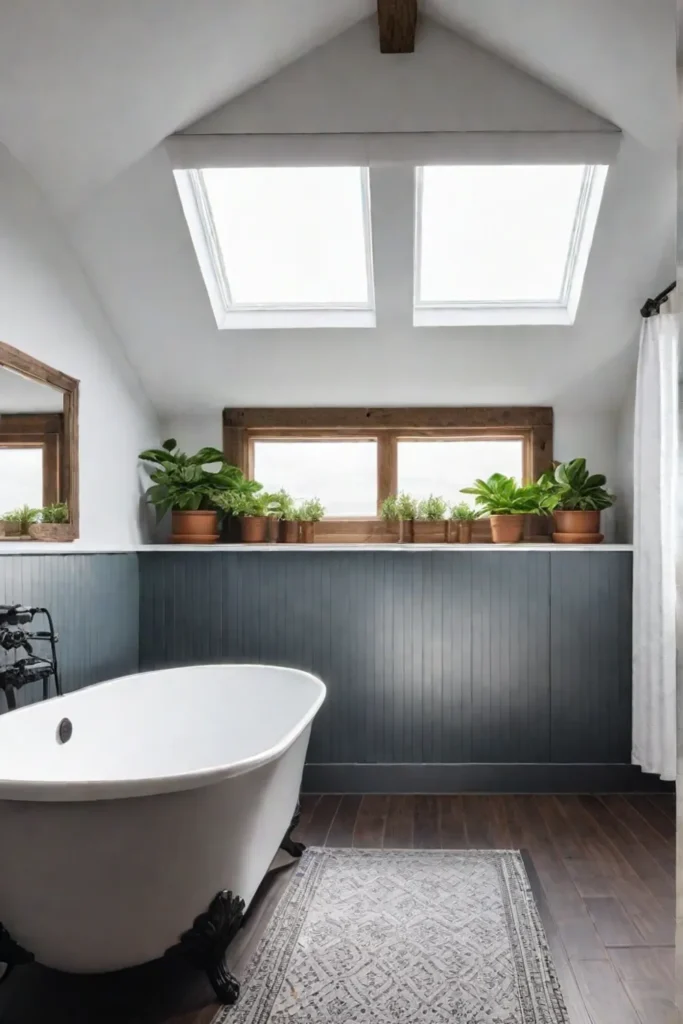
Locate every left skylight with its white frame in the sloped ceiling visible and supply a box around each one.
[176,167,375,328]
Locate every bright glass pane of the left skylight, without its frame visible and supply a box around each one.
[201,167,370,306]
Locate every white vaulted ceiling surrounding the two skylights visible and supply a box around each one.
[0,0,677,415]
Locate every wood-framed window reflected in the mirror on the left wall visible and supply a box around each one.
[0,413,67,512]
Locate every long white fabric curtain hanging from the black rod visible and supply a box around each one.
[633,313,679,779]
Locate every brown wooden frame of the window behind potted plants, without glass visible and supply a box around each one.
[223,407,553,544]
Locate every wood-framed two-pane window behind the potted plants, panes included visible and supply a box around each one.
[223,407,553,544]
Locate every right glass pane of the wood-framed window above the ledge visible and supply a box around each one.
[398,440,522,505]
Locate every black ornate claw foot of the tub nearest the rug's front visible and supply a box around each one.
[168,890,245,1007]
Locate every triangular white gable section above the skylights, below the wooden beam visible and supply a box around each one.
[185,17,615,135]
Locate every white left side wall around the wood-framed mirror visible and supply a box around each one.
[0,147,159,547]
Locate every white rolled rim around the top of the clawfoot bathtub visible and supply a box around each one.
[0,662,327,803]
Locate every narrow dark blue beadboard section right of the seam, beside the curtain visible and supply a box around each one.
[550,552,632,763]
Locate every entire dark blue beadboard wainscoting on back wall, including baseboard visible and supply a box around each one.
[138,549,656,793]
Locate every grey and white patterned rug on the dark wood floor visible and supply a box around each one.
[213,849,568,1024]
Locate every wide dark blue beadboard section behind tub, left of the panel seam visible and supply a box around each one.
[139,550,570,764]
